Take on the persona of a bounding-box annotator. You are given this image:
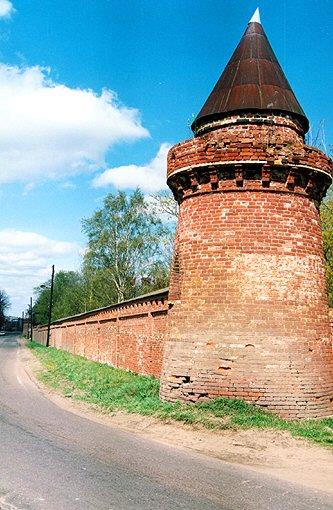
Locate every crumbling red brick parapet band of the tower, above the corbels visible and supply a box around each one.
[167,114,332,177]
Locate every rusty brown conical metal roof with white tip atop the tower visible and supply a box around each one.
[192,9,309,132]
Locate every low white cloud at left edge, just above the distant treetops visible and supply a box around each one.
[0,229,80,316]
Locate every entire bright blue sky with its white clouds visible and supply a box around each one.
[0,0,333,314]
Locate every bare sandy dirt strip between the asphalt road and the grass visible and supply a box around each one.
[19,344,333,492]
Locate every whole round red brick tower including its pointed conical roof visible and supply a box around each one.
[161,11,333,418]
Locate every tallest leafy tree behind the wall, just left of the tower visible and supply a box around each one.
[82,189,172,306]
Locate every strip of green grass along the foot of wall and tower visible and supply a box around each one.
[27,342,333,446]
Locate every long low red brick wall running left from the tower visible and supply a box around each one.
[34,290,168,377]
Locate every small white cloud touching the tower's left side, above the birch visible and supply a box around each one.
[93,143,171,193]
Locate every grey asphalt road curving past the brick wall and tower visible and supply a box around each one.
[0,336,333,510]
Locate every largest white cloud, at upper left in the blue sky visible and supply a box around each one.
[0,63,149,183]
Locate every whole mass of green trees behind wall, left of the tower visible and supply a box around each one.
[34,190,174,324]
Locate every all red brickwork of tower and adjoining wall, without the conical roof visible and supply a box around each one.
[31,110,333,418]
